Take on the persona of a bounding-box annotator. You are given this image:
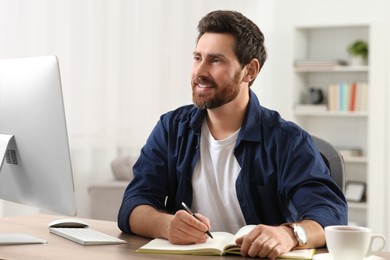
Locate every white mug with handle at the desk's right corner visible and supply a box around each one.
[325,225,386,260]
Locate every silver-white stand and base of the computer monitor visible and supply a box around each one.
[0,134,47,246]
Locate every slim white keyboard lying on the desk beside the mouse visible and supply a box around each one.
[49,228,126,246]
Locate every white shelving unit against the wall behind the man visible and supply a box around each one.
[292,24,386,230]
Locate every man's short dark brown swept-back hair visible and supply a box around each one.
[197,10,267,75]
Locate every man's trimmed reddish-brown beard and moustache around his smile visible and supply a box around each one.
[192,71,240,109]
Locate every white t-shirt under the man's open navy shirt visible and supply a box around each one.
[192,120,246,234]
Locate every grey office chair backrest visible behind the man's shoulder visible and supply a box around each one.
[311,135,345,192]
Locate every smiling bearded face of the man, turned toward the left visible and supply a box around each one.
[191,33,242,109]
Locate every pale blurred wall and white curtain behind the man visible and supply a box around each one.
[0,0,390,246]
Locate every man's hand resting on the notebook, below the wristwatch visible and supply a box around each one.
[236,225,297,259]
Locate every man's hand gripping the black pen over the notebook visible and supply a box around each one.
[167,210,210,244]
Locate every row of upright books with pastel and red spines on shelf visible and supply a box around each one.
[328,82,368,112]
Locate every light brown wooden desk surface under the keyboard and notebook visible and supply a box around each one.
[0,214,390,260]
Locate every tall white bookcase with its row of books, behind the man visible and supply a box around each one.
[291,25,377,230]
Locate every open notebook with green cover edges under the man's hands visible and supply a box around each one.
[136,225,315,259]
